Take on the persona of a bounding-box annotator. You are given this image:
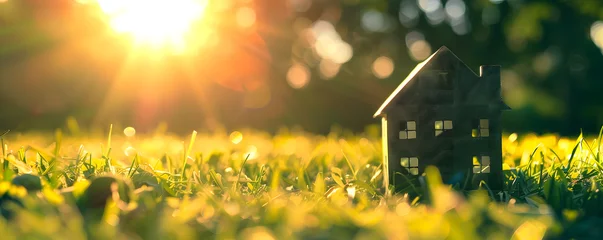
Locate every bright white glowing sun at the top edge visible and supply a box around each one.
[98,0,208,50]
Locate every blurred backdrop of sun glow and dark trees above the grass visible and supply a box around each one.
[0,0,603,135]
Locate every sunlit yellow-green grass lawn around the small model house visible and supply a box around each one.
[0,125,603,240]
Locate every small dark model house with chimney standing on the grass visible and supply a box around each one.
[374,47,510,190]
